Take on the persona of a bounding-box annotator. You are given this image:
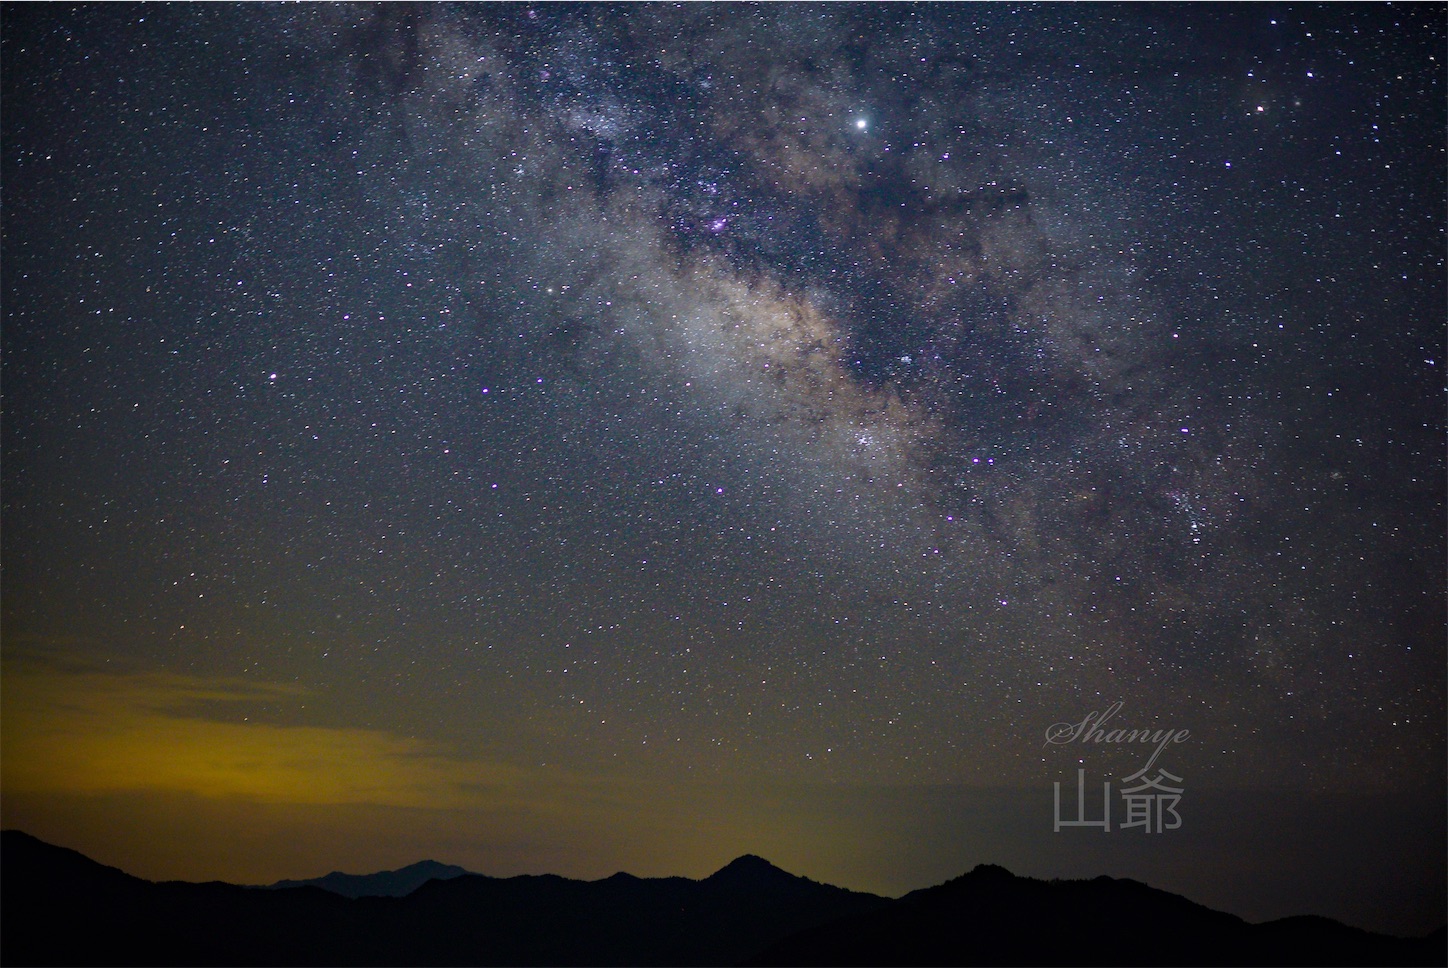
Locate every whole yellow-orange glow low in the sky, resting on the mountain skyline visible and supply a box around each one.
[0,657,886,890]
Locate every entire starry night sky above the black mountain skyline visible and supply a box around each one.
[0,4,1448,933]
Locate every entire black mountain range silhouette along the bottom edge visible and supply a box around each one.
[0,831,1445,965]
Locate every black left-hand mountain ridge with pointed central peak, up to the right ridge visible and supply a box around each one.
[0,831,889,965]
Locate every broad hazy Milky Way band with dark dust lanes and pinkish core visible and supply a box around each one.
[272,7,1413,708]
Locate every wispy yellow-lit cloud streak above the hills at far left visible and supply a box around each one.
[0,658,518,809]
